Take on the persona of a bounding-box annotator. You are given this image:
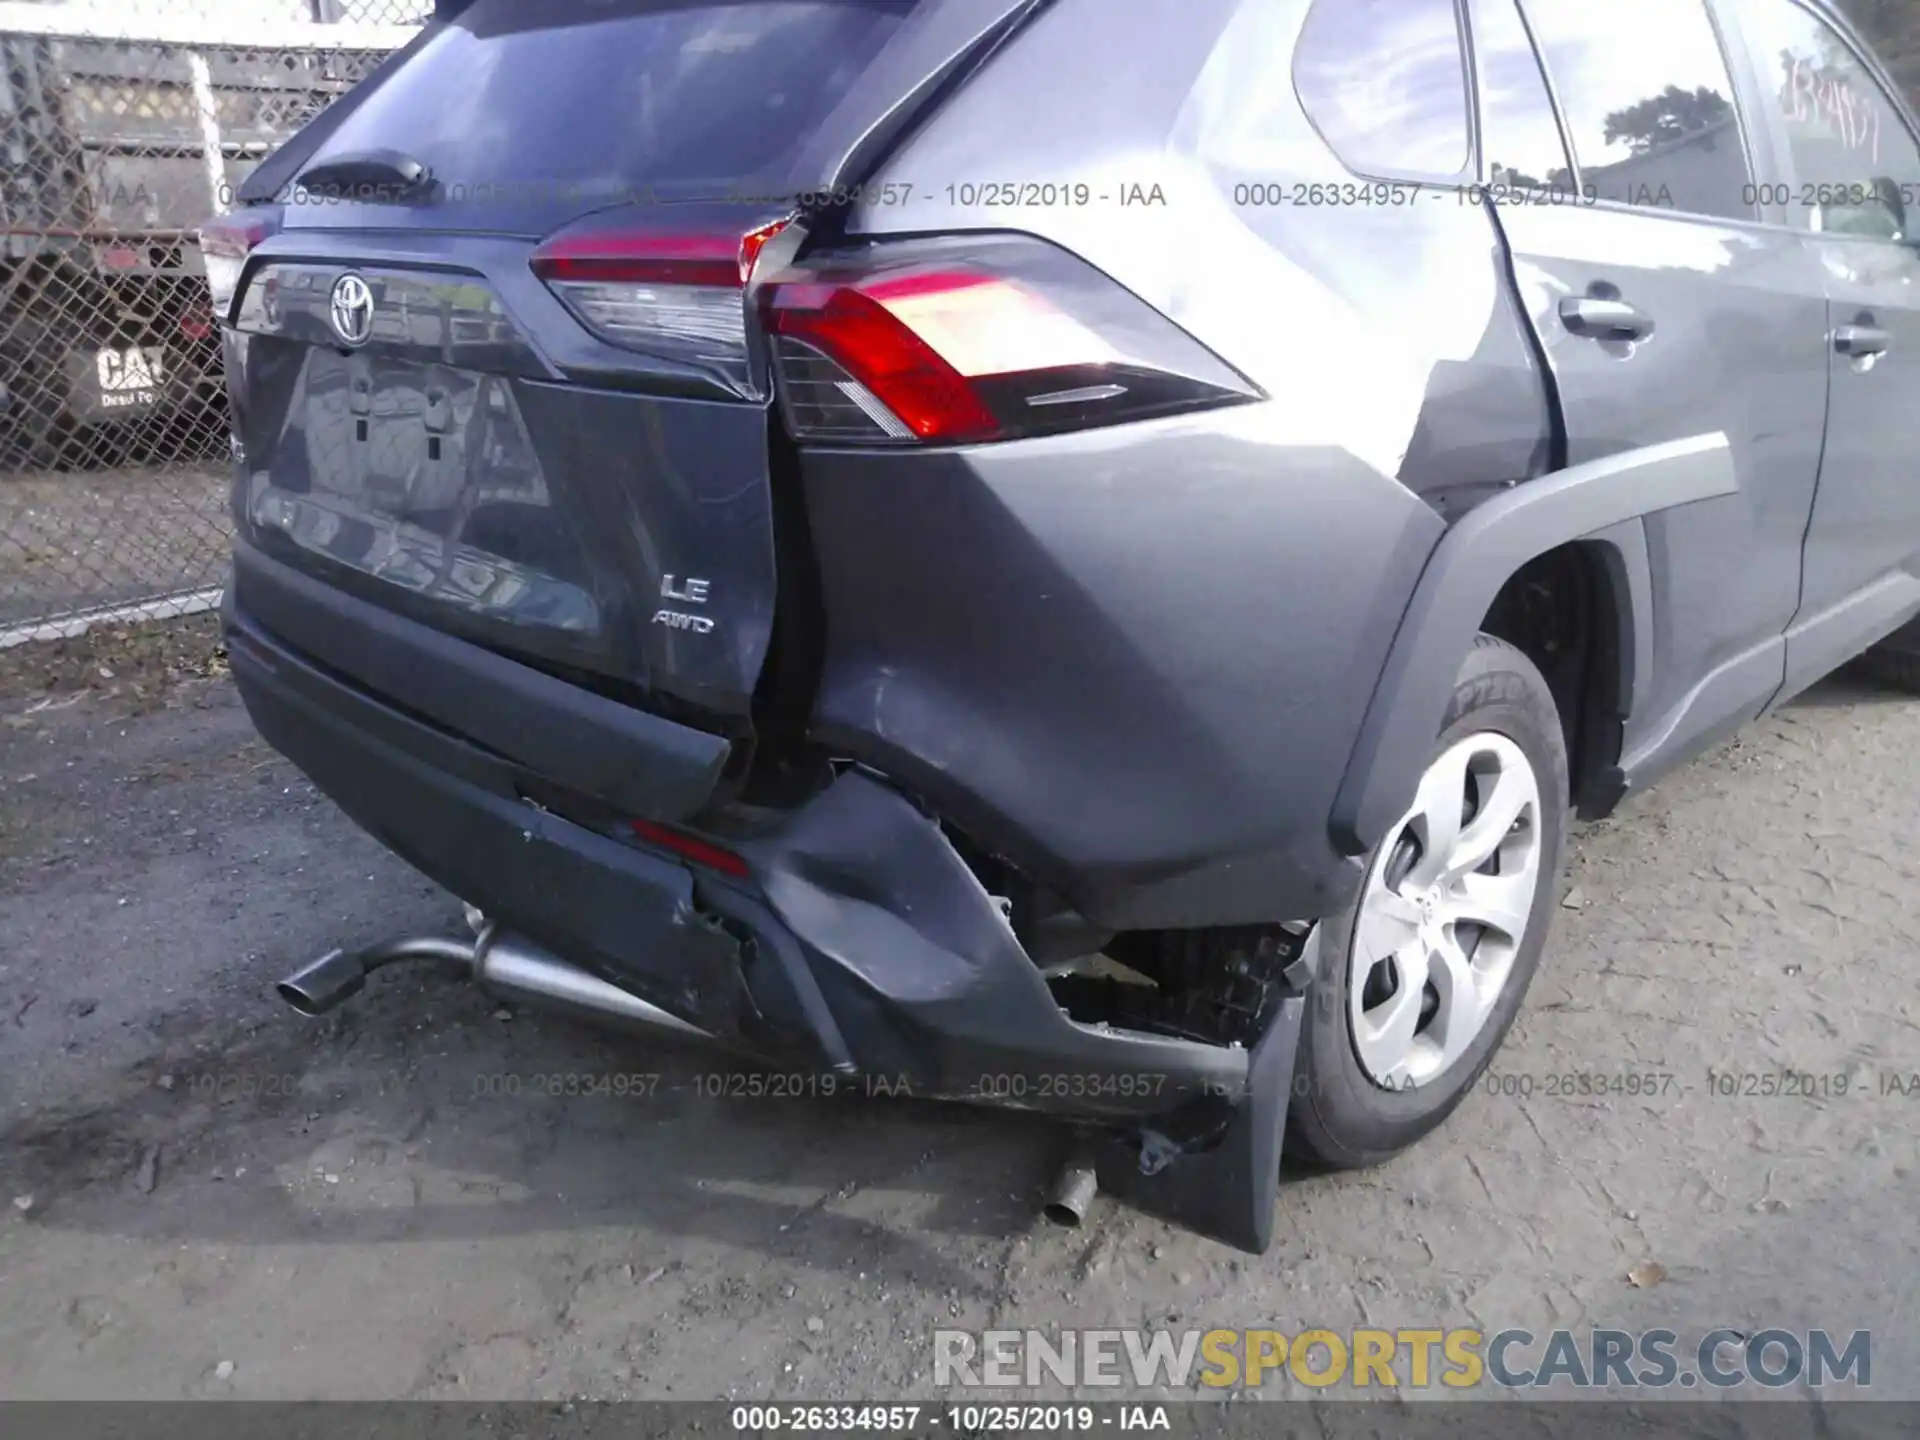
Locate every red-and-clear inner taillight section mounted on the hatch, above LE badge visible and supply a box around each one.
[534,217,789,388]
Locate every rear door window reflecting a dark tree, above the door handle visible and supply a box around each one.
[1524,0,1755,221]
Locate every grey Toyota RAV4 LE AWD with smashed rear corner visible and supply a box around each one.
[205,0,1920,1248]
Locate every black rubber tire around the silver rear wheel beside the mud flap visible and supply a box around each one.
[1286,636,1567,1169]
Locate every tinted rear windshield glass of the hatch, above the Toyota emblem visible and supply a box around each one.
[309,0,916,204]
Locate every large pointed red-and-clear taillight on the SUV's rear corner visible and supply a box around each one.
[760,236,1261,444]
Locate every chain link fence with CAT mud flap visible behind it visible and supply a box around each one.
[0,0,432,649]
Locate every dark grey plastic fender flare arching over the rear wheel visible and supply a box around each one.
[1329,434,1738,854]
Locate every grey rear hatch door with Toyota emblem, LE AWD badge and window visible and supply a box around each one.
[230,0,960,730]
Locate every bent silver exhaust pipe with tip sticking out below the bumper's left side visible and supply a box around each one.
[275,922,710,1039]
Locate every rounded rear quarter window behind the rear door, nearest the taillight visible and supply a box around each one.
[1294,0,1473,182]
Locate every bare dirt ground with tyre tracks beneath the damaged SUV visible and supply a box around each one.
[0,629,1920,1400]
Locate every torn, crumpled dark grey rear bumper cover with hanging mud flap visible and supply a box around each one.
[225,568,1311,1250]
